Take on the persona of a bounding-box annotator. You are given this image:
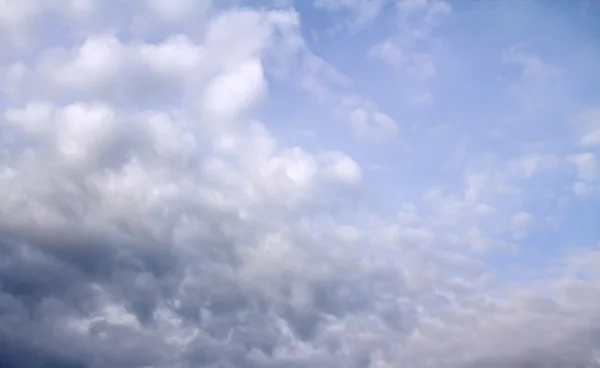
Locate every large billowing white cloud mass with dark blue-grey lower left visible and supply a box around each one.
[0,0,600,368]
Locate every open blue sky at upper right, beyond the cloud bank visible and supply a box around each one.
[267,1,599,267]
